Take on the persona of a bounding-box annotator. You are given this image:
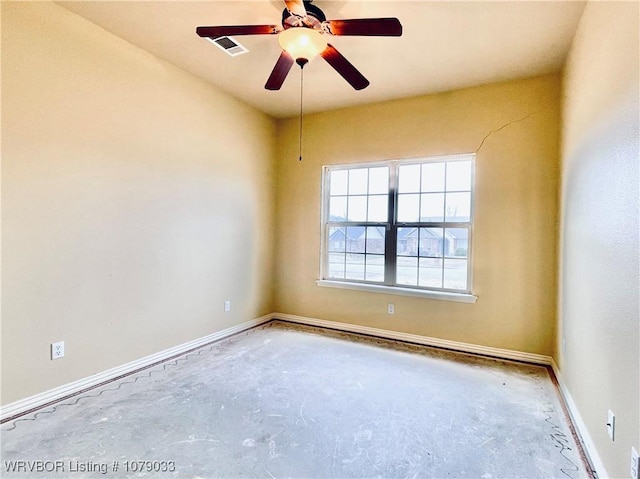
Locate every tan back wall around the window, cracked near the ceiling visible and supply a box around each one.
[276,76,560,355]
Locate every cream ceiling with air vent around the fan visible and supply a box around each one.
[57,0,585,118]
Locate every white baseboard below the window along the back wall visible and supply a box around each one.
[271,313,552,366]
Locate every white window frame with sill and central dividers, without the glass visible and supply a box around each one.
[316,153,477,303]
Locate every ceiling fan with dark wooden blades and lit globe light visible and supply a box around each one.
[196,0,402,90]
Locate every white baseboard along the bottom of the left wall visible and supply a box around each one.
[0,314,273,421]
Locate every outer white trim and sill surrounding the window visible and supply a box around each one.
[316,153,478,304]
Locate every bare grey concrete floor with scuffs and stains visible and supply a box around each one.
[0,322,589,479]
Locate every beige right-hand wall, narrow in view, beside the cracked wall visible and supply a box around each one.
[557,2,640,477]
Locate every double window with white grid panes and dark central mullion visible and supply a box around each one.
[321,155,474,302]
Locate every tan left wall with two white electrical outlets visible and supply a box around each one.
[2,2,275,404]
